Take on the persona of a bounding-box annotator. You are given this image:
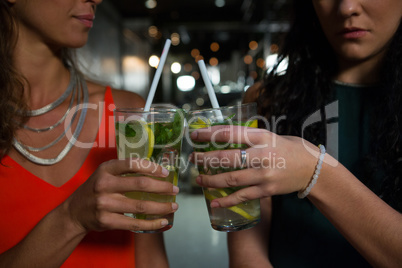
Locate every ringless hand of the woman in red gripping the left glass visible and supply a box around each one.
[65,159,179,232]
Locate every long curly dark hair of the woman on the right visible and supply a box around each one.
[257,0,402,211]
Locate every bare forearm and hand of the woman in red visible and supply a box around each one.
[0,160,176,268]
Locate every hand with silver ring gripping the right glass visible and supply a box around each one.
[191,125,319,207]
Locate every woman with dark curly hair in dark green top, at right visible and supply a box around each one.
[192,0,402,267]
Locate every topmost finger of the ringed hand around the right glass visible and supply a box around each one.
[190,125,274,148]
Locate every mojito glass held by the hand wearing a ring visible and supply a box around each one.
[187,103,260,232]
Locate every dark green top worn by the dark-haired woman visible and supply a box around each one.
[269,84,378,268]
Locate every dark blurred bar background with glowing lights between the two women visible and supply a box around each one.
[82,0,289,109]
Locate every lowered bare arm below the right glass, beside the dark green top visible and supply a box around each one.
[228,198,272,268]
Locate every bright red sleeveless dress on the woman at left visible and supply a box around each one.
[0,87,135,268]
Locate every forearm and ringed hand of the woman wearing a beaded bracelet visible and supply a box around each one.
[191,126,402,267]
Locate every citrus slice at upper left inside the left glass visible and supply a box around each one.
[119,121,155,159]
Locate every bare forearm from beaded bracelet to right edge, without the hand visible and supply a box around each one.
[308,155,402,267]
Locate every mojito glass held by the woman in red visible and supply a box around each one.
[114,108,185,233]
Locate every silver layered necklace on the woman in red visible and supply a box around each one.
[13,68,88,165]
